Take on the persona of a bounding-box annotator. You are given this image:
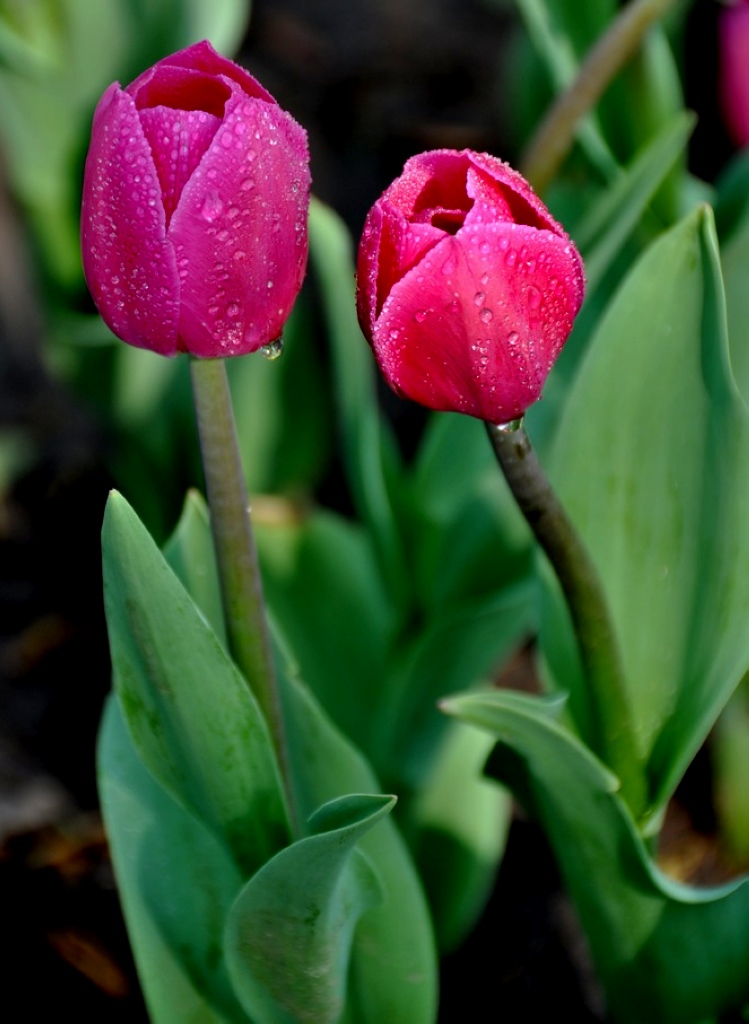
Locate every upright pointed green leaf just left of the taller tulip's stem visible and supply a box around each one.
[102,493,288,876]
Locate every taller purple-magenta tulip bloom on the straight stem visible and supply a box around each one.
[81,42,309,358]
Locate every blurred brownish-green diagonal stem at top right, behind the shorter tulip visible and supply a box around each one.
[521,0,674,193]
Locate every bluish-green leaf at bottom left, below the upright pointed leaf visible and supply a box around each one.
[97,696,247,1024]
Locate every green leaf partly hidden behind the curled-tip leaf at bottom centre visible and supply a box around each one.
[281,673,436,1024]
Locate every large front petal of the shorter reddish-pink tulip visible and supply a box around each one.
[373,221,583,423]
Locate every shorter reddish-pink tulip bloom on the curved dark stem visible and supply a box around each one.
[357,150,584,423]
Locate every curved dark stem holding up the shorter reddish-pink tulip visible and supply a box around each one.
[486,420,647,815]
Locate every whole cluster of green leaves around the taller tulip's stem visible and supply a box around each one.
[99,495,435,1024]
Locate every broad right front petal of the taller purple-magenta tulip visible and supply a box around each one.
[169,87,309,357]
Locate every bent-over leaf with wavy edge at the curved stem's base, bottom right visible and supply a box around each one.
[444,691,749,1024]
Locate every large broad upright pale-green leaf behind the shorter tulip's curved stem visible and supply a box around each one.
[541,208,749,811]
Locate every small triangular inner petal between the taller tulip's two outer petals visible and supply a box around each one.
[140,106,223,224]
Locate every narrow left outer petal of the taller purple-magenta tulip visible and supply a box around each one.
[81,84,179,355]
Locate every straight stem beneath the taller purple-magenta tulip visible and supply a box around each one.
[190,359,293,820]
